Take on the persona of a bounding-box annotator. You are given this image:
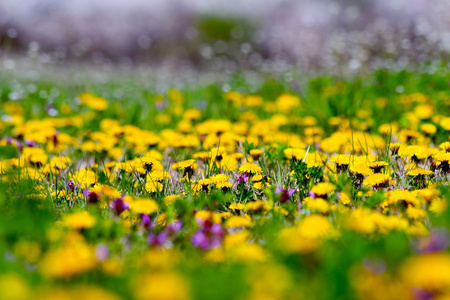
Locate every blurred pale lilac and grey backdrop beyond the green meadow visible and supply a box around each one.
[0,0,450,74]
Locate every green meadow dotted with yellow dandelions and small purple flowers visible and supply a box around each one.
[0,71,450,300]
